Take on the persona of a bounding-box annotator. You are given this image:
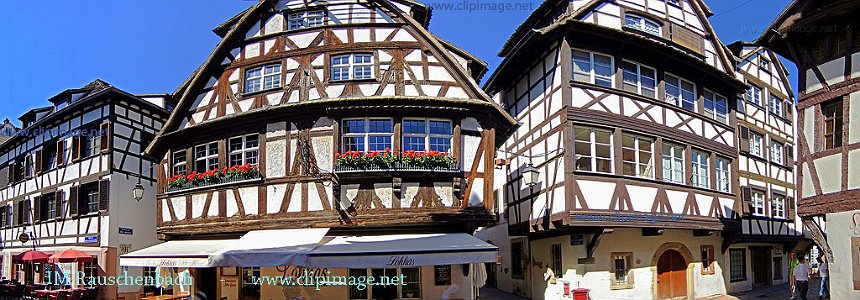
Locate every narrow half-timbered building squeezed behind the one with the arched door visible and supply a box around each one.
[724,42,808,291]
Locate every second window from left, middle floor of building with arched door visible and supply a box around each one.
[621,134,654,178]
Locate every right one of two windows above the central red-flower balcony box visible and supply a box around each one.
[402,119,454,152]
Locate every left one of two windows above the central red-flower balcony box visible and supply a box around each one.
[341,118,396,152]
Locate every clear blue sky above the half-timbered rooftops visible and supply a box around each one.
[0,0,797,124]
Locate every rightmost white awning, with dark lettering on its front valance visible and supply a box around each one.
[307,233,499,268]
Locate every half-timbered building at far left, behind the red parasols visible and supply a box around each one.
[0,80,172,299]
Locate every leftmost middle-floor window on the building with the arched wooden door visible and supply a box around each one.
[573,126,613,173]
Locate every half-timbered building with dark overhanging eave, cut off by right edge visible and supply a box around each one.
[758,0,860,299]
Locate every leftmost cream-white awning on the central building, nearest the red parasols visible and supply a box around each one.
[119,239,239,268]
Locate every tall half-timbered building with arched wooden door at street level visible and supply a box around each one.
[480,0,744,299]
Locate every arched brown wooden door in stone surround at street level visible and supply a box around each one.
[657,250,687,299]
